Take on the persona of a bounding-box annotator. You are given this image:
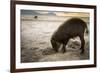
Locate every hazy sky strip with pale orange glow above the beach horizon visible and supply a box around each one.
[21,10,89,17]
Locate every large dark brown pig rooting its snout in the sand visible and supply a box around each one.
[51,18,87,54]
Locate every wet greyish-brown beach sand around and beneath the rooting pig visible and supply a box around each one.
[21,15,89,63]
